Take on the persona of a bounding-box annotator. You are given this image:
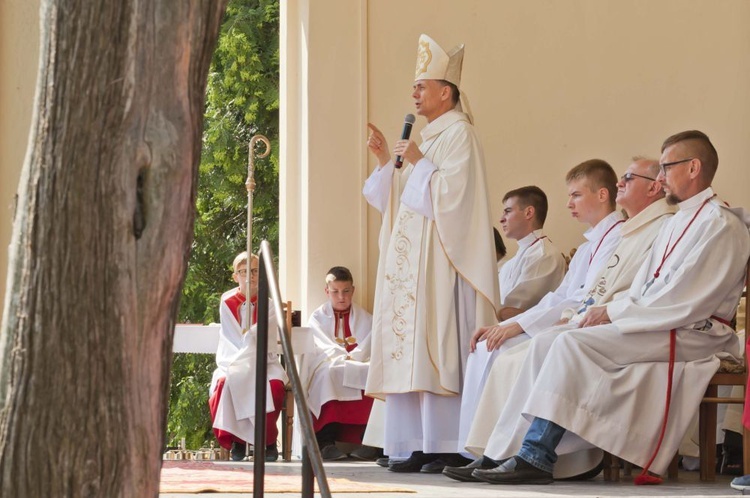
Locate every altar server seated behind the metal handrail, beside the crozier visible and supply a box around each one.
[208,252,287,462]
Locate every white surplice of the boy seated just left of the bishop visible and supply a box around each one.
[298,302,372,417]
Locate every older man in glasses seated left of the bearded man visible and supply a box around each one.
[443,157,675,481]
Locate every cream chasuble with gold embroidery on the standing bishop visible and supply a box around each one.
[365,111,500,397]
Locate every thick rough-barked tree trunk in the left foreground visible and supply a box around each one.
[0,0,226,498]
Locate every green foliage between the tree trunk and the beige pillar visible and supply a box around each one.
[167,0,279,448]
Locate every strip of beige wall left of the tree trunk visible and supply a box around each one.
[0,0,39,322]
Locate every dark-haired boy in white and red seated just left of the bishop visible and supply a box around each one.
[299,266,376,460]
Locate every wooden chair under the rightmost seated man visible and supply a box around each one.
[698,265,750,481]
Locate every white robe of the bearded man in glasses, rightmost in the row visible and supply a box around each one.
[486,188,750,474]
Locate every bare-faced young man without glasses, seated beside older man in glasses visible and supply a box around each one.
[458,159,623,458]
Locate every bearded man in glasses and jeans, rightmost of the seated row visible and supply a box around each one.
[473,130,750,484]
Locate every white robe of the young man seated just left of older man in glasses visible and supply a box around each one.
[458,211,623,451]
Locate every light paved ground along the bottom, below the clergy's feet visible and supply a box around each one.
[160,461,741,498]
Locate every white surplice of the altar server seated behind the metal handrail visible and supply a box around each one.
[208,289,287,444]
